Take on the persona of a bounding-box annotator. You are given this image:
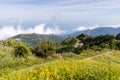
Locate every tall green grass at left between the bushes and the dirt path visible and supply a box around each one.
[0,46,48,77]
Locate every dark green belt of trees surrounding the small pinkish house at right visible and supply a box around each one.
[58,34,120,54]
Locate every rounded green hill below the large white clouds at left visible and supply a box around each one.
[12,33,64,46]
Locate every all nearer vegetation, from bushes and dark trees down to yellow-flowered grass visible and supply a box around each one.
[0,34,120,80]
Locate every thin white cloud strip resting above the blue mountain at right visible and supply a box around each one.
[73,24,120,31]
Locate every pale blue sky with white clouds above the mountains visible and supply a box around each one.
[0,0,120,40]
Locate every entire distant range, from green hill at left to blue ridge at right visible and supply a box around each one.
[8,27,120,46]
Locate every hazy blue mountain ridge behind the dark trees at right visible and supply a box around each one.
[65,27,120,37]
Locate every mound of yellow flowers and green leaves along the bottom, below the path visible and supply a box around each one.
[1,59,120,80]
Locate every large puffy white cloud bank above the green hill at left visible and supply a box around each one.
[0,23,66,40]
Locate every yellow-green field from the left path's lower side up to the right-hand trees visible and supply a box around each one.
[0,50,120,80]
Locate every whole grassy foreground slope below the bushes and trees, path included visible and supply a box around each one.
[0,46,120,80]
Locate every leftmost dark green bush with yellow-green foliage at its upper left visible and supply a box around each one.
[3,39,31,57]
